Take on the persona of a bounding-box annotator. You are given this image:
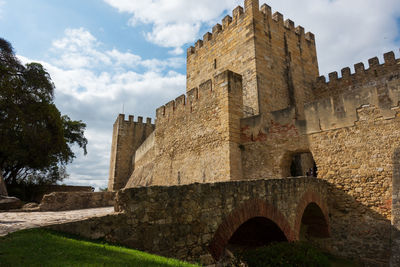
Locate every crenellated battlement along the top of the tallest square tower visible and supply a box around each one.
[187,1,315,58]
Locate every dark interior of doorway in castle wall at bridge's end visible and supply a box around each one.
[290,152,318,177]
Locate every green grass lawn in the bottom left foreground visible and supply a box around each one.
[0,229,200,267]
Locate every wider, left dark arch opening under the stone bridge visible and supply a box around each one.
[228,217,288,249]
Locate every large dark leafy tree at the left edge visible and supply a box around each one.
[0,38,88,184]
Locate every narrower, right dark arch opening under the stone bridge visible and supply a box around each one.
[299,202,329,241]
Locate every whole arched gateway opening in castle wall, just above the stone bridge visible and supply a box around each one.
[281,151,318,177]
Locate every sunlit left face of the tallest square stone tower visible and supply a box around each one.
[186,0,259,114]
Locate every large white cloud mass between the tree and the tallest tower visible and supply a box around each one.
[19,28,186,191]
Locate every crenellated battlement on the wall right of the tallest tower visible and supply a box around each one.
[313,51,400,98]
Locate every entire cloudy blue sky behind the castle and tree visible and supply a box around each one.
[0,0,400,187]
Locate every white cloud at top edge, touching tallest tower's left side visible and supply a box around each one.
[104,0,242,54]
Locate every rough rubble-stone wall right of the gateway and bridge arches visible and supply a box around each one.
[309,106,400,262]
